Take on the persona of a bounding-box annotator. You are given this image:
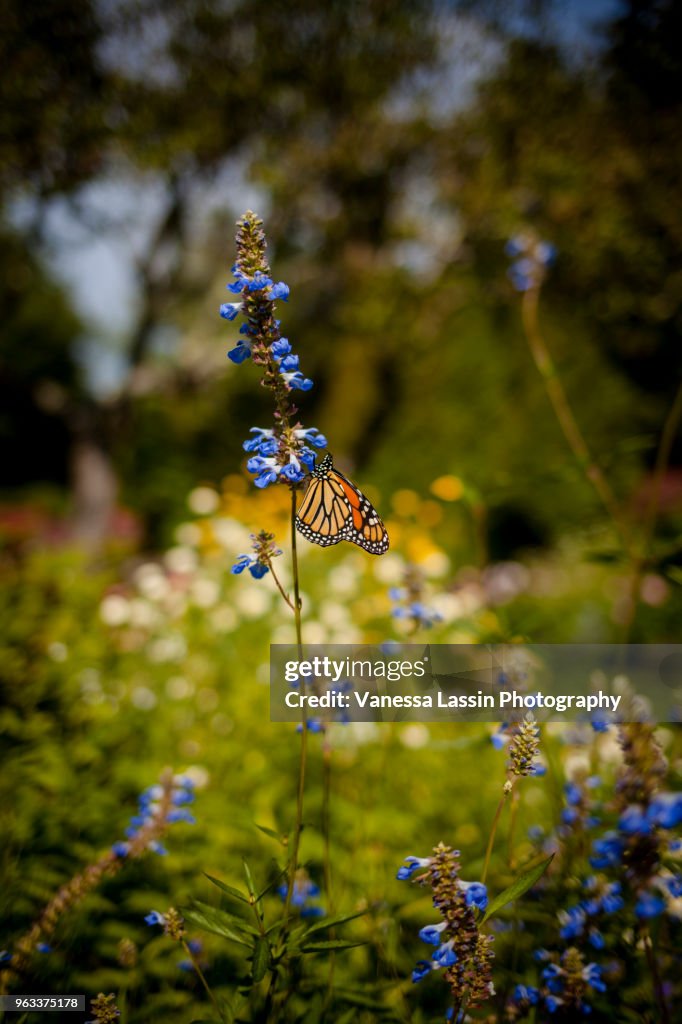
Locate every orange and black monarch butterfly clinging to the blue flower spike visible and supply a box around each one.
[296,454,388,555]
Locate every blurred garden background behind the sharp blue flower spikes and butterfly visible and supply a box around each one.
[0,0,682,1024]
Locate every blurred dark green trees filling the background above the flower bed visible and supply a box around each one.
[0,0,682,550]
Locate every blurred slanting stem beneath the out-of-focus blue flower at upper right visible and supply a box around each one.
[521,287,634,558]
